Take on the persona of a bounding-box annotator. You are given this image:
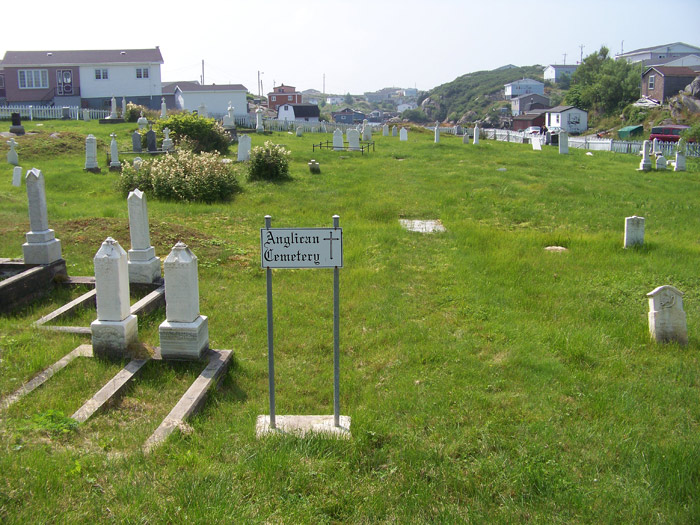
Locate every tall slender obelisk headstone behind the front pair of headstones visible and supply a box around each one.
[126,188,160,283]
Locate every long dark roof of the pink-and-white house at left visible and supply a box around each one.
[3,47,163,67]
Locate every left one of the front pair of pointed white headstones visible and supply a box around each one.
[90,237,138,359]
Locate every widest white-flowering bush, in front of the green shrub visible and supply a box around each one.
[117,150,240,202]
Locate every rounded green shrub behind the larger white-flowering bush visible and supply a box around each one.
[156,112,231,155]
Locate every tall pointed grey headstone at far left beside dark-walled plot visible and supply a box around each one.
[22,168,61,264]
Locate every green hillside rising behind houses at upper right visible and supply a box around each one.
[419,65,543,122]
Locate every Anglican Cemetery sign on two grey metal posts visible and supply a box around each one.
[260,215,349,430]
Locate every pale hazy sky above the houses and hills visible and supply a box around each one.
[0,0,700,94]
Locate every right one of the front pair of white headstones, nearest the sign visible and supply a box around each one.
[158,242,209,360]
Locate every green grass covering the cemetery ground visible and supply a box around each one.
[0,122,700,523]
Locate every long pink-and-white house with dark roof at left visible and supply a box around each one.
[2,47,163,109]
